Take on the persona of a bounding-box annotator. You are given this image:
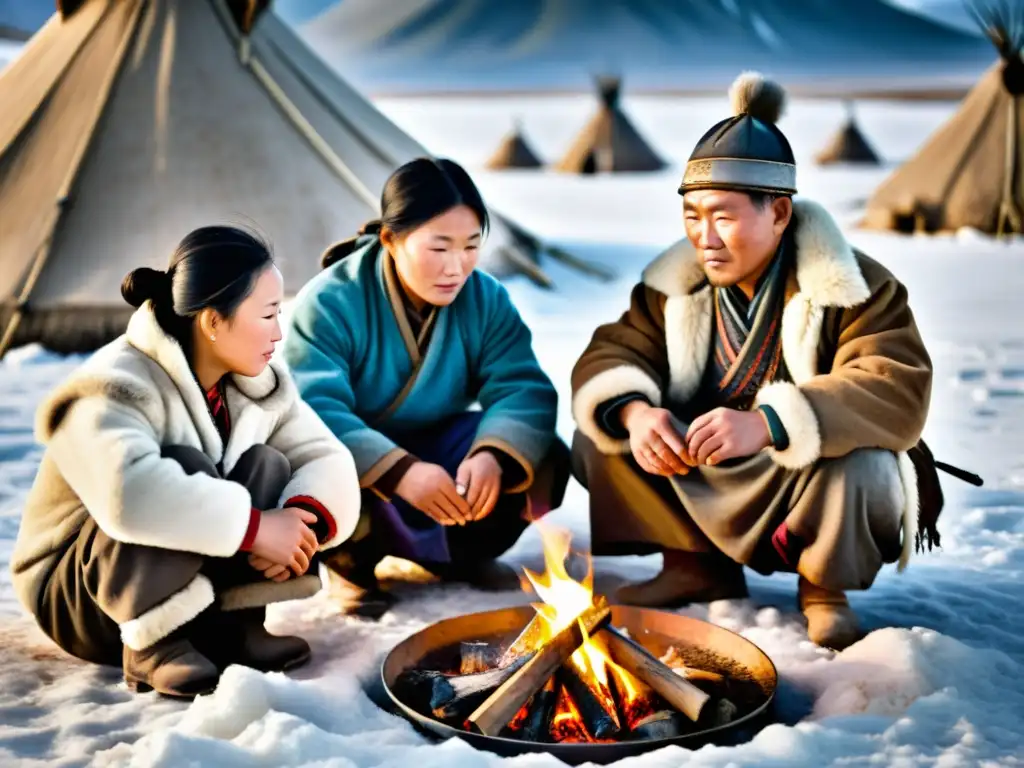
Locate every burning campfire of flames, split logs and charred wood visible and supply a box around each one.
[392,528,770,744]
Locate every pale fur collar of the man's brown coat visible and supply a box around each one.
[643,200,870,308]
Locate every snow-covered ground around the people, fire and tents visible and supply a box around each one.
[0,97,1024,768]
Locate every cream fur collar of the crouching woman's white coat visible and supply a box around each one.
[35,302,296,450]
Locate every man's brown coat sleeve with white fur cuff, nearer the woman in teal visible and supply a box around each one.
[572,283,669,454]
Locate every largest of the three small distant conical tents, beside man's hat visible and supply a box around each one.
[555,78,665,174]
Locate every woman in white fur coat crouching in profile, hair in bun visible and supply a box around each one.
[11,226,359,697]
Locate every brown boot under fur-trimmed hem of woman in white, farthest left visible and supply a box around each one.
[122,628,220,698]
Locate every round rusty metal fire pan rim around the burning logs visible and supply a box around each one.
[381,605,778,765]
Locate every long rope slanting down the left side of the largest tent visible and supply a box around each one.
[0,2,144,358]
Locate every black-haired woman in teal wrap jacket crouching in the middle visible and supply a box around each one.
[284,158,568,612]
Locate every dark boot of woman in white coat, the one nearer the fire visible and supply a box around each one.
[197,607,311,672]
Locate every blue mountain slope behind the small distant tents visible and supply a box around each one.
[299,0,994,92]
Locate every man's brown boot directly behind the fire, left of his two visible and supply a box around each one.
[615,550,749,608]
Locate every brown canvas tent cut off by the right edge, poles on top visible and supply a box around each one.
[862,2,1024,234]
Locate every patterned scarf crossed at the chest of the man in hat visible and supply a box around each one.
[712,239,790,410]
